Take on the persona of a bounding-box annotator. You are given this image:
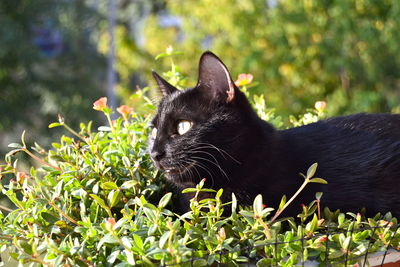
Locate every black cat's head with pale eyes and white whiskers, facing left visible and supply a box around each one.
[149,52,254,186]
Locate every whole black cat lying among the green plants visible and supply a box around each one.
[149,52,400,219]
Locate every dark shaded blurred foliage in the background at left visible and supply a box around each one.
[0,0,105,153]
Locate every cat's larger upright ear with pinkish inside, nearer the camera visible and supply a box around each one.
[196,51,235,103]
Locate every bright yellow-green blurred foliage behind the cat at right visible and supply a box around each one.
[141,0,400,116]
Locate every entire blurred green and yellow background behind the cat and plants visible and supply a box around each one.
[0,0,400,154]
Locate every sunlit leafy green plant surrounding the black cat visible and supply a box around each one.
[0,50,400,266]
